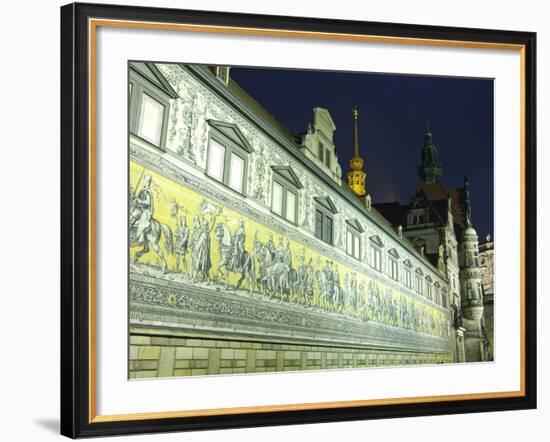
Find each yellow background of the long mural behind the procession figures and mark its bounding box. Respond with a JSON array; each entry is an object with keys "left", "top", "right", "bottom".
[{"left": 130, "top": 162, "right": 449, "bottom": 337}]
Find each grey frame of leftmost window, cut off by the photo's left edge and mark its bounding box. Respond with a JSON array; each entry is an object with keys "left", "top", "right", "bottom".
[{"left": 128, "top": 69, "right": 171, "bottom": 152}]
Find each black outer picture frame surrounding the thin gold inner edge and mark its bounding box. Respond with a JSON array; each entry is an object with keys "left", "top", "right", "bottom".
[{"left": 60, "top": 4, "right": 536, "bottom": 438}]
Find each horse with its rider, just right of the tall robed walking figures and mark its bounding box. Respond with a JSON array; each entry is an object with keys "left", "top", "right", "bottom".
[{"left": 216, "top": 223, "right": 255, "bottom": 293}]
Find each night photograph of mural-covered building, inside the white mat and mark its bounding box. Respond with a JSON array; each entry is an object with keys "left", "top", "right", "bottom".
[{"left": 132, "top": 59, "right": 498, "bottom": 380}]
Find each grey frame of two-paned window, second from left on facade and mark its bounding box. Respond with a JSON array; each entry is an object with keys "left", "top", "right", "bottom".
[{"left": 204, "top": 124, "right": 250, "bottom": 197}]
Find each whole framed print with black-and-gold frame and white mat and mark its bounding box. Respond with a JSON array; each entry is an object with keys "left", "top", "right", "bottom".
[{"left": 61, "top": 4, "right": 536, "bottom": 438}]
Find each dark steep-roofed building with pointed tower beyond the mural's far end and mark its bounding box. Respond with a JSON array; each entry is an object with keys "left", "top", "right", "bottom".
[{"left": 375, "top": 128, "right": 492, "bottom": 361}]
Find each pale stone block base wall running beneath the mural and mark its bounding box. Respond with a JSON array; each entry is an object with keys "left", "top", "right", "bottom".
[{"left": 129, "top": 334, "right": 458, "bottom": 379}]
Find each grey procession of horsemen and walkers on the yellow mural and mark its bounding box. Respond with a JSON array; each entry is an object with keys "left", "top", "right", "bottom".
[{"left": 129, "top": 174, "right": 448, "bottom": 336}]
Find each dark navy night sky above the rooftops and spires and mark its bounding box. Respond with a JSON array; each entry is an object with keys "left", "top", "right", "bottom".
[{"left": 231, "top": 68, "right": 494, "bottom": 242}]
